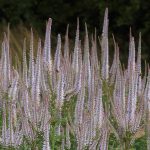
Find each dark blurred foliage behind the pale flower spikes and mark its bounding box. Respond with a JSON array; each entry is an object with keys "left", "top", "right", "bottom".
[{"left": 0, "top": 0, "right": 150, "bottom": 63}]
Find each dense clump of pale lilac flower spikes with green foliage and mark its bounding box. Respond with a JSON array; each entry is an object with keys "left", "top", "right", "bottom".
[{"left": 0, "top": 8, "right": 150, "bottom": 150}]
